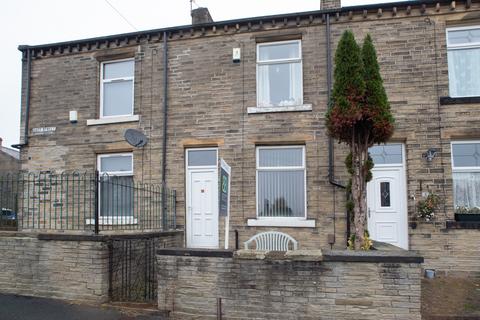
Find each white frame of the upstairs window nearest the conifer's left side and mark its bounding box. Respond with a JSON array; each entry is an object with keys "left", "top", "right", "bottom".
[{"left": 255, "top": 39, "right": 304, "bottom": 108}]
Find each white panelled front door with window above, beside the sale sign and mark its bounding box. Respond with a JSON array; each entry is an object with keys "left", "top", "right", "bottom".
[{"left": 186, "top": 148, "right": 218, "bottom": 248}]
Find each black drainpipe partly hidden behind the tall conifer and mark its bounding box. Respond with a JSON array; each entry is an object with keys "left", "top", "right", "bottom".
[{"left": 325, "top": 13, "right": 350, "bottom": 245}]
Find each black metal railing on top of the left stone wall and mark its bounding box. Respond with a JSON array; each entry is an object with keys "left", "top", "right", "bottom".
[{"left": 0, "top": 172, "right": 176, "bottom": 233}]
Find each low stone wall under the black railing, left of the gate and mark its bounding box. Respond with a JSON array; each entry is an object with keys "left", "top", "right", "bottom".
[{"left": 0, "top": 232, "right": 183, "bottom": 303}]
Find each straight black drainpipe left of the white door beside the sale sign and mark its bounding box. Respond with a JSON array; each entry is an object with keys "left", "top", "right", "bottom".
[{"left": 162, "top": 31, "right": 168, "bottom": 225}]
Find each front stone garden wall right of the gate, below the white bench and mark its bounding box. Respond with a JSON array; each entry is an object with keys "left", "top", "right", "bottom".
[{"left": 157, "top": 249, "right": 422, "bottom": 319}]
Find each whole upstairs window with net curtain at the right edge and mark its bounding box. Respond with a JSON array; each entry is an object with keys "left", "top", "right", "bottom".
[{"left": 447, "top": 26, "right": 480, "bottom": 97}]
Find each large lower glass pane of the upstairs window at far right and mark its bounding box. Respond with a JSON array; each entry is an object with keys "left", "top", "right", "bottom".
[{"left": 448, "top": 48, "right": 480, "bottom": 97}]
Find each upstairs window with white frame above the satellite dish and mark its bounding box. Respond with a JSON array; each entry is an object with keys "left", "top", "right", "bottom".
[{"left": 100, "top": 59, "right": 135, "bottom": 118}]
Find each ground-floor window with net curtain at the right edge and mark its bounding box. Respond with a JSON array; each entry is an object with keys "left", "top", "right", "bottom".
[{"left": 452, "top": 141, "right": 480, "bottom": 211}]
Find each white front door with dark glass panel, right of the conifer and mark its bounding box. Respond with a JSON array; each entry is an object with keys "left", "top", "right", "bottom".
[{"left": 367, "top": 144, "right": 408, "bottom": 249}]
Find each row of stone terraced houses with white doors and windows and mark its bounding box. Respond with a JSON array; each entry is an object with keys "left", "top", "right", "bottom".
[{"left": 7, "top": 0, "right": 480, "bottom": 276}]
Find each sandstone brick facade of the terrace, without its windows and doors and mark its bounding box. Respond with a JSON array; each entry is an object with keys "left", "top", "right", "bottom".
[{"left": 15, "top": 1, "right": 480, "bottom": 269}]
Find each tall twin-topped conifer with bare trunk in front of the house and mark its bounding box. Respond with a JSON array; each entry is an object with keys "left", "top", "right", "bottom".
[{"left": 326, "top": 30, "right": 394, "bottom": 250}]
